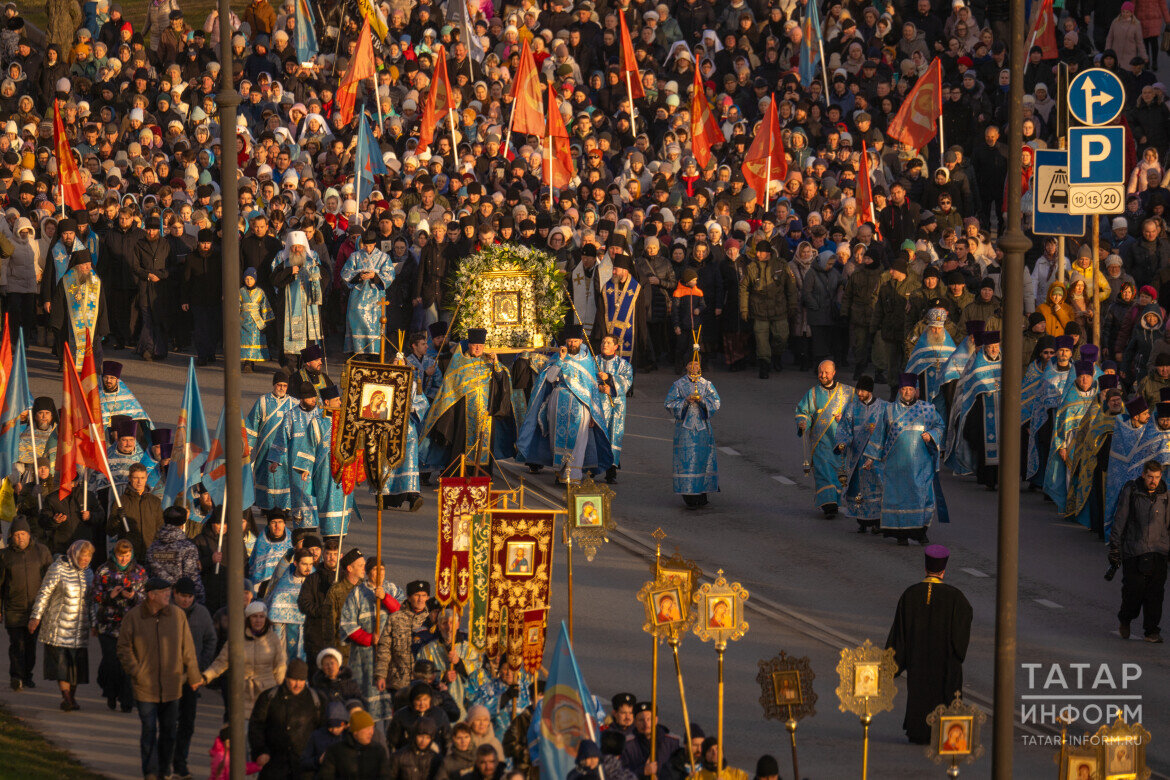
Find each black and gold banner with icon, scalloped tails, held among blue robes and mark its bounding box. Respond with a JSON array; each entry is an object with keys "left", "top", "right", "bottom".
[{"left": 330, "top": 359, "right": 414, "bottom": 491}]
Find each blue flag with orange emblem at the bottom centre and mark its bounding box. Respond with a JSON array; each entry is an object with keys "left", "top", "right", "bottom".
[{"left": 528, "top": 621, "right": 599, "bottom": 780}]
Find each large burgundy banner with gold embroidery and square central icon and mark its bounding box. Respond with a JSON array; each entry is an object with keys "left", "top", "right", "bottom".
[{"left": 484, "top": 509, "right": 556, "bottom": 656}]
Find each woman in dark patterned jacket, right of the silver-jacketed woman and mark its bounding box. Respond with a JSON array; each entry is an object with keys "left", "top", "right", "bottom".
[{"left": 94, "top": 539, "right": 146, "bottom": 712}]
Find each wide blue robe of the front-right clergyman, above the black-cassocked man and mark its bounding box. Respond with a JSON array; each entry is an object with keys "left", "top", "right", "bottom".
[{"left": 865, "top": 400, "right": 947, "bottom": 531}]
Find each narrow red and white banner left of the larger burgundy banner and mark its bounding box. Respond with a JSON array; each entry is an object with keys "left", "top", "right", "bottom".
[{"left": 435, "top": 476, "right": 491, "bottom": 607}]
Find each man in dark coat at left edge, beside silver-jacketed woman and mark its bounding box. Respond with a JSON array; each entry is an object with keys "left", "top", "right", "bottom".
[{"left": 0, "top": 516, "right": 53, "bottom": 691}]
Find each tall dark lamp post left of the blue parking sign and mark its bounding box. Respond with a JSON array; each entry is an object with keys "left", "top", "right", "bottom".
[{"left": 991, "top": 2, "right": 1031, "bottom": 780}]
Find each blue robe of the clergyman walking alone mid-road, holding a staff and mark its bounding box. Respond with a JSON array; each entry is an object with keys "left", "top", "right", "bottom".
[{"left": 666, "top": 377, "right": 720, "bottom": 496}]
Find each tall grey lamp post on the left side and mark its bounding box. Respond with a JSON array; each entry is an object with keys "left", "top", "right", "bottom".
[{"left": 215, "top": 0, "right": 248, "bottom": 780}]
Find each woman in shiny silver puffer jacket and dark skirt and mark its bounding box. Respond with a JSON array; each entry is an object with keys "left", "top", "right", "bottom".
[{"left": 28, "top": 539, "right": 94, "bottom": 712}]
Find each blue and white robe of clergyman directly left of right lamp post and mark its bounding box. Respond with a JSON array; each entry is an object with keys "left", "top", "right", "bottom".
[{"left": 943, "top": 350, "right": 1003, "bottom": 477}]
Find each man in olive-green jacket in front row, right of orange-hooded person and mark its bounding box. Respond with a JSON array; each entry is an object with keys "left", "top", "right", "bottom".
[{"left": 739, "top": 240, "right": 799, "bottom": 379}]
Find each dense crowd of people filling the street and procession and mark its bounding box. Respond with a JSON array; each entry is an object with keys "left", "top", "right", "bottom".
[{"left": 0, "top": 0, "right": 1170, "bottom": 780}]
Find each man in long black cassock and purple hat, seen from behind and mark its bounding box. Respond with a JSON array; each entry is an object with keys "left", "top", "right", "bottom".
[{"left": 886, "top": 545, "right": 971, "bottom": 745}]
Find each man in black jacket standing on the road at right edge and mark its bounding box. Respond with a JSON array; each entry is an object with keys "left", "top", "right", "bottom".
[{"left": 1109, "top": 460, "right": 1170, "bottom": 643}]
